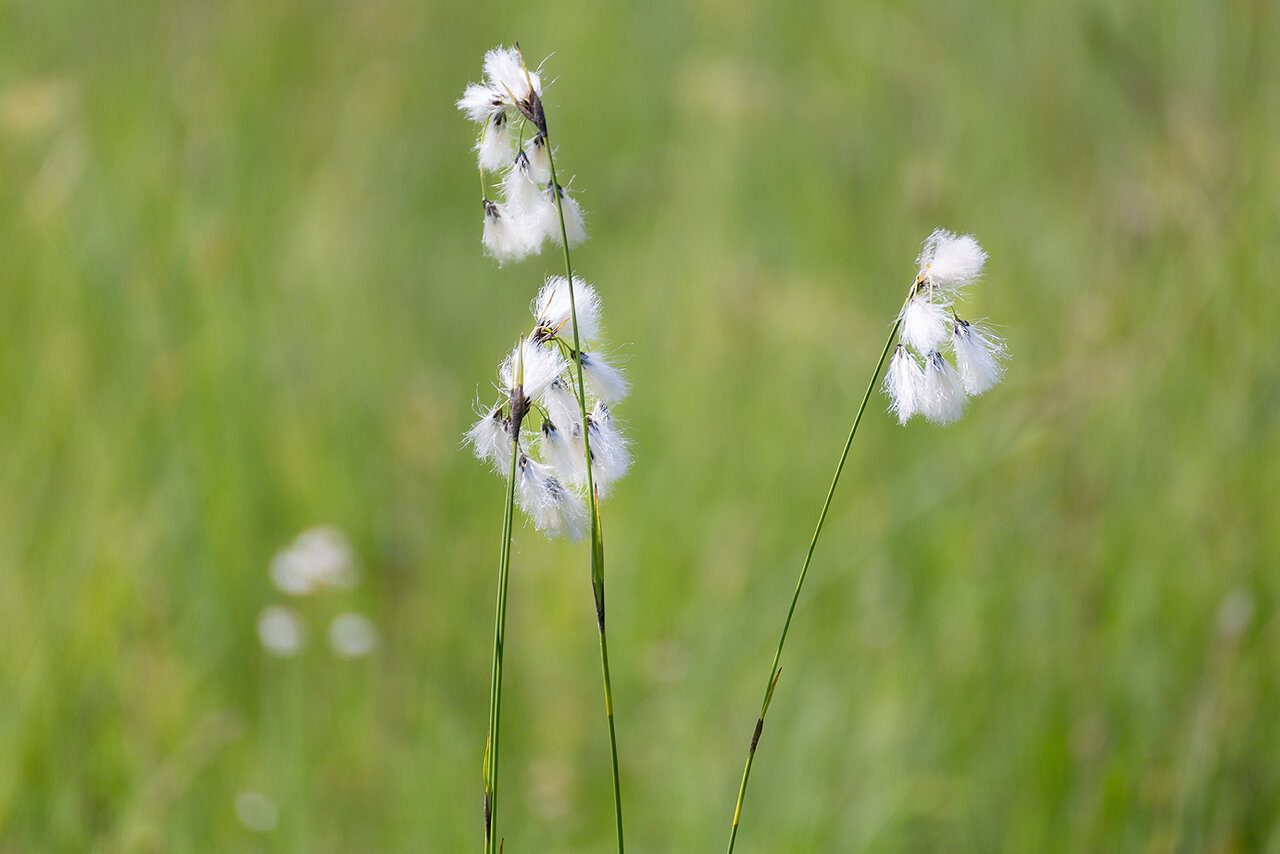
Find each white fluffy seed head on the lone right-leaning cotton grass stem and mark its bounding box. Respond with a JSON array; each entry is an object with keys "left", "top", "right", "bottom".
[{"left": 884, "top": 228, "right": 1007, "bottom": 425}]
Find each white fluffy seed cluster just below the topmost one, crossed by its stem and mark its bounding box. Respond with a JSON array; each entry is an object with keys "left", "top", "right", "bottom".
[{"left": 466, "top": 277, "right": 632, "bottom": 539}]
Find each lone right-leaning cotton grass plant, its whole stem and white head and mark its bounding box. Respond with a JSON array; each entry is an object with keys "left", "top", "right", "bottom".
[{"left": 728, "top": 229, "right": 1007, "bottom": 854}]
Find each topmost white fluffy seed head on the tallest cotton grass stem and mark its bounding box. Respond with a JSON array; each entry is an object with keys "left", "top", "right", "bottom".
[{"left": 458, "top": 46, "right": 586, "bottom": 264}]
